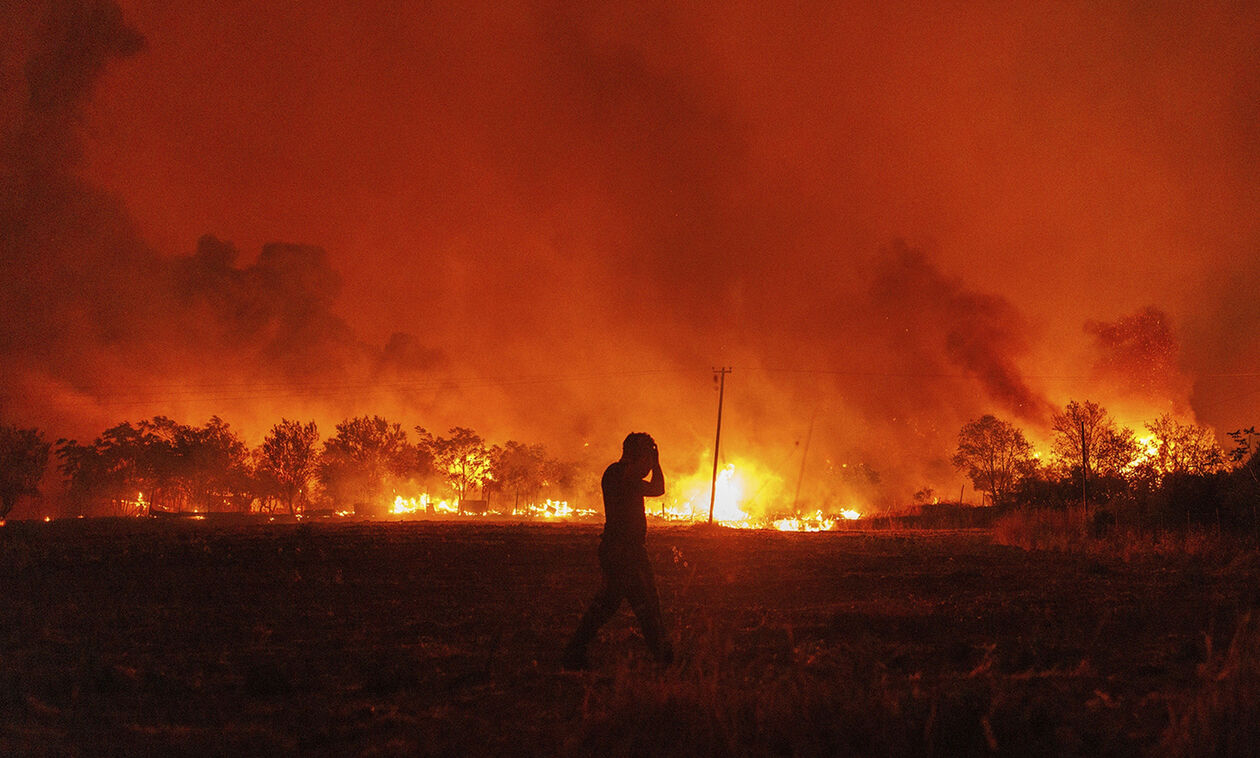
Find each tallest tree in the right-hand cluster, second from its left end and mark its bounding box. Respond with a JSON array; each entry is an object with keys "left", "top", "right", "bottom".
[{"left": 1052, "top": 400, "right": 1138, "bottom": 501}]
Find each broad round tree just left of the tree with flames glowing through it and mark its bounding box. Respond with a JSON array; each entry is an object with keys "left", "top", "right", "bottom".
[{"left": 319, "top": 416, "right": 415, "bottom": 507}]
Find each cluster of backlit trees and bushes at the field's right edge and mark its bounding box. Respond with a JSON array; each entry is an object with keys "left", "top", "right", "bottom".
[{"left": 953, "top": 400, "right": 1260, "bottom": 529}]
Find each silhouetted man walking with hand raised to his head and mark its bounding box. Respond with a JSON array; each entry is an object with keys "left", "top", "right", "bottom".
[{"left": 564, "top": 432, "right": 674, "bottom": 669}]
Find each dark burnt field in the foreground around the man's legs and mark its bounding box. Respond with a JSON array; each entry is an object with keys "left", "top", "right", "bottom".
[{"left": 0, "top": 520, "right": 1260, "bottom": 755}]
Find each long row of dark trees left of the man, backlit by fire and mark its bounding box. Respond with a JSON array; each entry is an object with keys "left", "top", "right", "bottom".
[{"left": 0, "top": 416, "right": 577, "bottom": 519}]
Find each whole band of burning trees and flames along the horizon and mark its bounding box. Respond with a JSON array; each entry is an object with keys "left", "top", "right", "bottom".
[{"left": 0, "top": 390, "right": 1260, "bottom": 531}]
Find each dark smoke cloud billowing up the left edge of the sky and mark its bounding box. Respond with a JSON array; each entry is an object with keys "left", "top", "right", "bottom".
[{"left": 0, "top": 1, "right": 440, "bottom": 434}]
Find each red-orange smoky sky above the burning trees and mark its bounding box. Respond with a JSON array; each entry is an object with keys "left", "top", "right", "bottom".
[{"left": 4, "top": 0, "right": 1260, "bottom": 503}]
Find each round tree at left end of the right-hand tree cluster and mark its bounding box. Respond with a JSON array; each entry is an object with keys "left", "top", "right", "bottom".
[{"left": 953, "top": 414, "right": 1036, "bottom": 505}]
